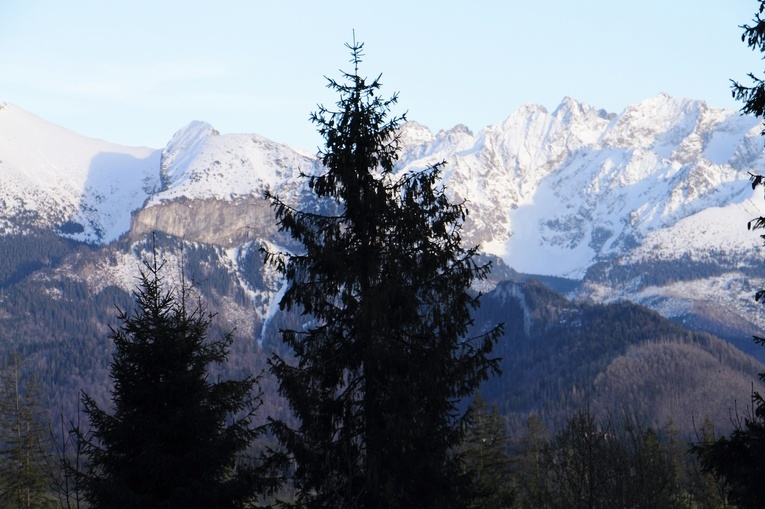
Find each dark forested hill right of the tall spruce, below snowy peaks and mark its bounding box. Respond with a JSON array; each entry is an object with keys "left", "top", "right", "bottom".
[{"left": 476, "top": 280, "right": 762, "bottom": 431}]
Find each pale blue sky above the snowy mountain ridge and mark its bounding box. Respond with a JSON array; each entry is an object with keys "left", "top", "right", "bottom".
[{"left": 0, "top": 0, "right": 765, "bottom": 152}]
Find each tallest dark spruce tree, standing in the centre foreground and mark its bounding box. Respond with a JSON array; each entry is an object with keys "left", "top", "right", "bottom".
[{"left": 266, "top": 41, "right": 500, "bottom": 509}]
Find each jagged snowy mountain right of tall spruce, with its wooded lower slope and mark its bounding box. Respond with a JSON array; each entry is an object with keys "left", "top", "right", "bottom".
[{"left": 390, "top": 95, "right": 765, "bottom": 353}]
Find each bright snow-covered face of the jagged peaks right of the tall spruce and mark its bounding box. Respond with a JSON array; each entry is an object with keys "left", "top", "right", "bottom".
[{"left": 390, "top": 95, "right": 765, "bottom": 278}]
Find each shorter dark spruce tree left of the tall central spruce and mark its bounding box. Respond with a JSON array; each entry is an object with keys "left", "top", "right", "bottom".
[{"left": 72, "top": 253, "right": 269, "bottom": 509}]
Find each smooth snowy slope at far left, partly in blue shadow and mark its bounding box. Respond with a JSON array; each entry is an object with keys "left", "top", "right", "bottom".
[{"left": 0, "top": 104, "right": 160, "bottom": 242}]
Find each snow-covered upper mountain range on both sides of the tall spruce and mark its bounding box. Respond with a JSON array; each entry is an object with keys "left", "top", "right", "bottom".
[{"left": 0, "top": 95, "right": 765, "bottom": 348}]
